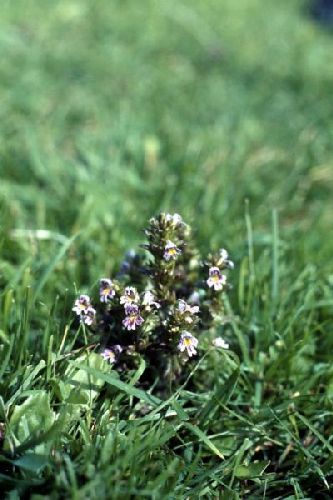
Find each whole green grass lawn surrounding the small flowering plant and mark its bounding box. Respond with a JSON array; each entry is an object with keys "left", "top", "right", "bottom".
[{"left": 0, "top": 0, "right": 333, "bottom": 499}]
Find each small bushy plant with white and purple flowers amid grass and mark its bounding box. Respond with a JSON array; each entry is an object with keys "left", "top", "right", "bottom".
[{"left": 73, "top": 213, "right": 234, "bottom": 382}]
